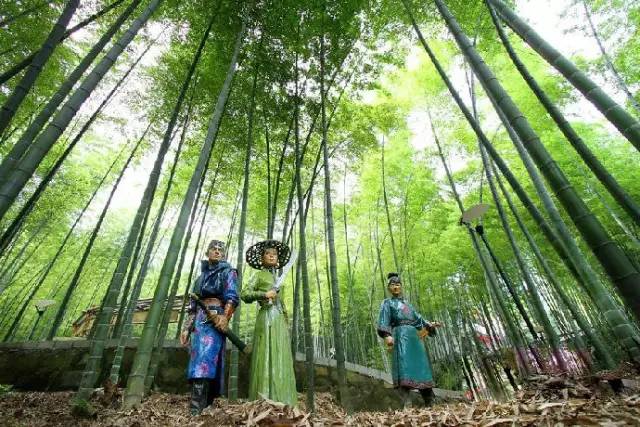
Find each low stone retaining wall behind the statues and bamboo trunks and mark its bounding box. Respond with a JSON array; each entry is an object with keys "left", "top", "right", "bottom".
[{"left": 0, "top": 339, "right": 462, "bottom": 410}]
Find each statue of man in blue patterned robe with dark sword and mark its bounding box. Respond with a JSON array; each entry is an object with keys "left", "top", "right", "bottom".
[{"left": 180, "top": 240, "right": 239, "bottom": 415}]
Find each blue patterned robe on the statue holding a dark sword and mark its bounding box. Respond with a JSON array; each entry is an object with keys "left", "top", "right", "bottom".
[{"left": 187, "top": 261, "right": 239, "bottom": 395}]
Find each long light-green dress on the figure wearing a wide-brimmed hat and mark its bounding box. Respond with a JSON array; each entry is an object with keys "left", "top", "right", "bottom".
[{"left": 242, "top": 269, "right": 298, "bottom": 406}]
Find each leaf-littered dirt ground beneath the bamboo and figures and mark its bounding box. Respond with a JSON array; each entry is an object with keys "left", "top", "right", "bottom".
[{"left": 0, "top": 377, "right": 640, "bottom": 427}]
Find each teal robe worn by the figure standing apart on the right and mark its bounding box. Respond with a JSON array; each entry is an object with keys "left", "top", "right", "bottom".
[{"left": 378, "top": 297, "right": 435, "bottom": 390}]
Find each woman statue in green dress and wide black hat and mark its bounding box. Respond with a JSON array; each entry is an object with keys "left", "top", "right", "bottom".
[{"left": 241, "top": 240, "right": 298, "bottom": 406}]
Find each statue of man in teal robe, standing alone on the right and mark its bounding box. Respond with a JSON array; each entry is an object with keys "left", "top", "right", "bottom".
[{"left": 378, "top": 273, "right": 441, "bottom": 407}]
